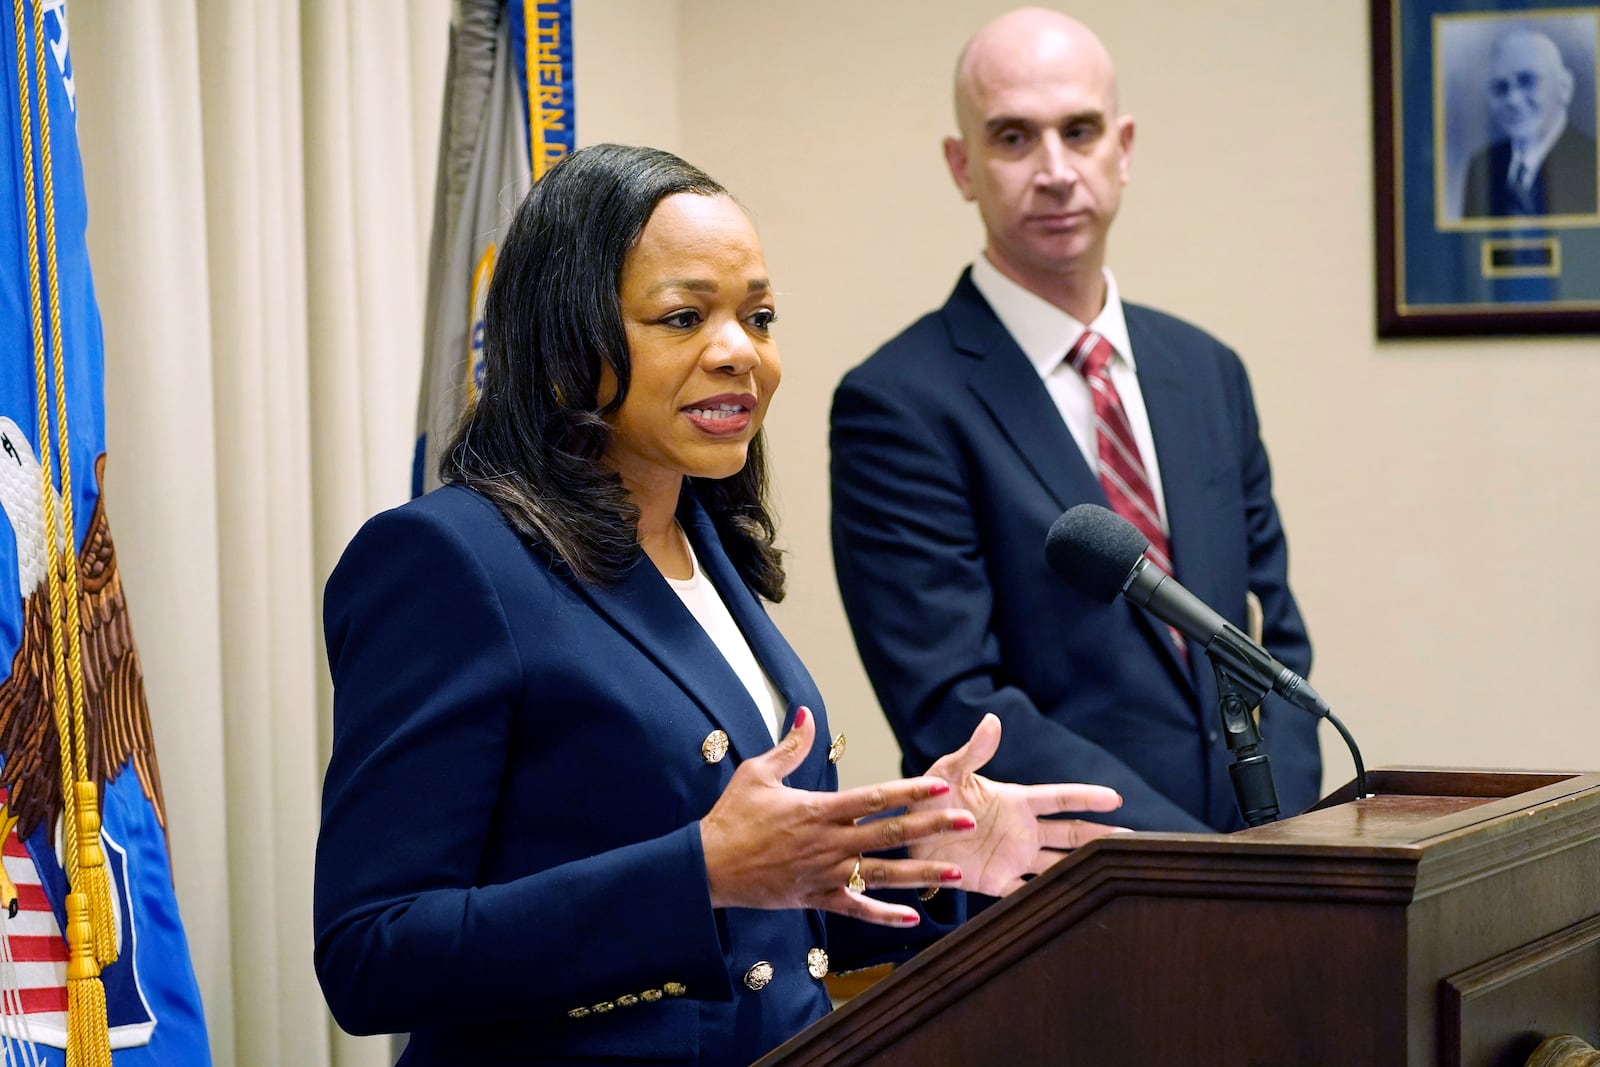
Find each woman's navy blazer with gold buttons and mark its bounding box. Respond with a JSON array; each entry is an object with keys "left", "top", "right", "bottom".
[{"left": 315, "top": 488, "right": 960, "bottom": 1065}]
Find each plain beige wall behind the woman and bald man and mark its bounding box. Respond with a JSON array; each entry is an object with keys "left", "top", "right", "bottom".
[{"left": 576, "top": 0, "right": 1600, "bottom": 787}]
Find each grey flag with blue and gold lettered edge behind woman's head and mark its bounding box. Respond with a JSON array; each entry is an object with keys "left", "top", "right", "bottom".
[{"left": 411, "top": 0, "right": 576, "bottom": 496}]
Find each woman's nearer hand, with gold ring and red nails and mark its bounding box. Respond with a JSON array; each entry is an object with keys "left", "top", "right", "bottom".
[{"left": 701, "top": 707, "right": 978, "bottom": 926}]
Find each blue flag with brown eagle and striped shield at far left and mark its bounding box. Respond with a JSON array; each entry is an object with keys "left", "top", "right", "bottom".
[{"left": 0, "top": 0, "right": 210, "bottom": 1067}]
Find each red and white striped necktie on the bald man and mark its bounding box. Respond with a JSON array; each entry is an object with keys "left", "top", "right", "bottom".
[{"left": 1067, "top": 330, "right": 1189, "bottom": 662}]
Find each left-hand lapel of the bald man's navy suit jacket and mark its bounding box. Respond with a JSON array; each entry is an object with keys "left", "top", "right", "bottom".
[{"left": 944, "top": 270, "right": 1106, "bottom": 510}]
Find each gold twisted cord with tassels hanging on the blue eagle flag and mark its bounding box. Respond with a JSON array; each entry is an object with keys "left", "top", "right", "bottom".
[{"left": 13, "top": 0, "right": 117, "bottom": 1067}]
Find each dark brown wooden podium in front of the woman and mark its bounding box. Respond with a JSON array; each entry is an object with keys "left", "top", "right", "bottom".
[{"left": 760, "top": 769, "right": 1600, "bottom": 1067}]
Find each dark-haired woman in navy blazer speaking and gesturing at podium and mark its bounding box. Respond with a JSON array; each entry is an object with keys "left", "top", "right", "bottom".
[{"left": 305, "top": 146, "right": 1120, "bottom": 1065}]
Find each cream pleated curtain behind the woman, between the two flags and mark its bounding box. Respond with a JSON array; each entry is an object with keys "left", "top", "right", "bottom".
[{"left": 69, "top": 0, "right": 450, "bottom": 1067}]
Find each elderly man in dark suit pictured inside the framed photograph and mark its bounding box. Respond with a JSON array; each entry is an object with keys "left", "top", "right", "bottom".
[{"left": 1461, "top": 27, "right": 1600, "bottom": 219}]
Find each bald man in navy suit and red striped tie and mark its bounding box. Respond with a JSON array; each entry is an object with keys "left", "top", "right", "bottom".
[{"left": 830, "top": 8, "right": 1322, "bottom": 832}]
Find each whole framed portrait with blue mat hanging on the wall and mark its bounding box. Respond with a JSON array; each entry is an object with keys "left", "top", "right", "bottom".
[{"left": 1371, "top": 0, "right": 1600, "bottom": 338}]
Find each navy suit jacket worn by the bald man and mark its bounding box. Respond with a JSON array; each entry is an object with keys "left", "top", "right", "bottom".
[{"left": 830, "top": 274, "right": 1322, "bottom": 832}]
